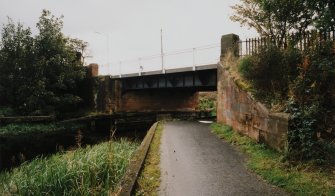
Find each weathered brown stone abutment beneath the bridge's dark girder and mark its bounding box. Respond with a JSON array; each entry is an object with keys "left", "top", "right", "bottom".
[{"left": 88, "top": 68, "right": 198, "bottom": 113}]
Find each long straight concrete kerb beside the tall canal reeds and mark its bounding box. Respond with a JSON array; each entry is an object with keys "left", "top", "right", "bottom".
[{"left": 112, "top": 122, "right": 158, "bottom": 196}]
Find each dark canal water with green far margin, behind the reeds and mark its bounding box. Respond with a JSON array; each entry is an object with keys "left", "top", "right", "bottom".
[{"left": 0, "top": 116, "right": 154, "bottom": 171}]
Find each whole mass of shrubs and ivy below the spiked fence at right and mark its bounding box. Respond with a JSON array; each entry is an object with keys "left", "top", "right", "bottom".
[{"left": 238, "top": 42, "right": 335, "bottom": 163}]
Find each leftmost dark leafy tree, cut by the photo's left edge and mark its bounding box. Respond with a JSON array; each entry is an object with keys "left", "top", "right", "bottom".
[{"left": 0, "top": 19, "right": 35, "bottom": 107}]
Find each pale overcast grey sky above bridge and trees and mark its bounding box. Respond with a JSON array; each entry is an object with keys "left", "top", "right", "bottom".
[{"left": 0, "top": 0, "right": 257, "bottom": 74}]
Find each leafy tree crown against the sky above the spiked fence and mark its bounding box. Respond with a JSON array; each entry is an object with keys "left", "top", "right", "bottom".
[{"left": 231, "top": 0, "right": 313, "bottom": 43}]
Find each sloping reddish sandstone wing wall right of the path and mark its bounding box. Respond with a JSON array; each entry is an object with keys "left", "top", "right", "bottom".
[{"left": 217, "top": 35, "right": 289, "bottom": 151}]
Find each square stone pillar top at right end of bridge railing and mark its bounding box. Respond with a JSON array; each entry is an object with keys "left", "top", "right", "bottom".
[{"left": 220, "top": 34, "right": 240, "bottom": 61}]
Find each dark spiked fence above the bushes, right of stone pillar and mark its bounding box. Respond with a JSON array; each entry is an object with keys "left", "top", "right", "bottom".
[{"left": 237, "top": 31, "right": 335, "bottom": 56}]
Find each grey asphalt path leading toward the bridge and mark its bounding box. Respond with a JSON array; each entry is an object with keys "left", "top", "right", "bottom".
[{"left": 159, "top": 121, "right": 286, "bottom": 196}]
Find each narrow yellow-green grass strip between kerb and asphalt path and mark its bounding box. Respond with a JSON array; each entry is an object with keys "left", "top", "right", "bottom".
[{"left": 135, "top": 122, "right": 163, "bottom": 196}]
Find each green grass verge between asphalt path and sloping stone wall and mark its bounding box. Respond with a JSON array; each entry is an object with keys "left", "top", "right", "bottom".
[{"left": 211, "top": 123, "right": 335, "bottom": 195}]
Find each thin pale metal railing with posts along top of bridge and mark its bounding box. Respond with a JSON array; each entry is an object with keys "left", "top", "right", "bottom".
[{"left": 99, "top": 43, "right": 221, "bottom": 77}]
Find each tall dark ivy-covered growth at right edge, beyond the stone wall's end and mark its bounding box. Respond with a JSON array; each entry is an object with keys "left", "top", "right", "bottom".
[{"left": 288, "top": 43, "right": 335, "bottom": 162}]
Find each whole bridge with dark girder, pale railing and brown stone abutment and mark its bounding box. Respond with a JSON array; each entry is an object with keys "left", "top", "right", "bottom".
[{"left": 91, "top": 34, "right": 239, "bottom": 113}]
